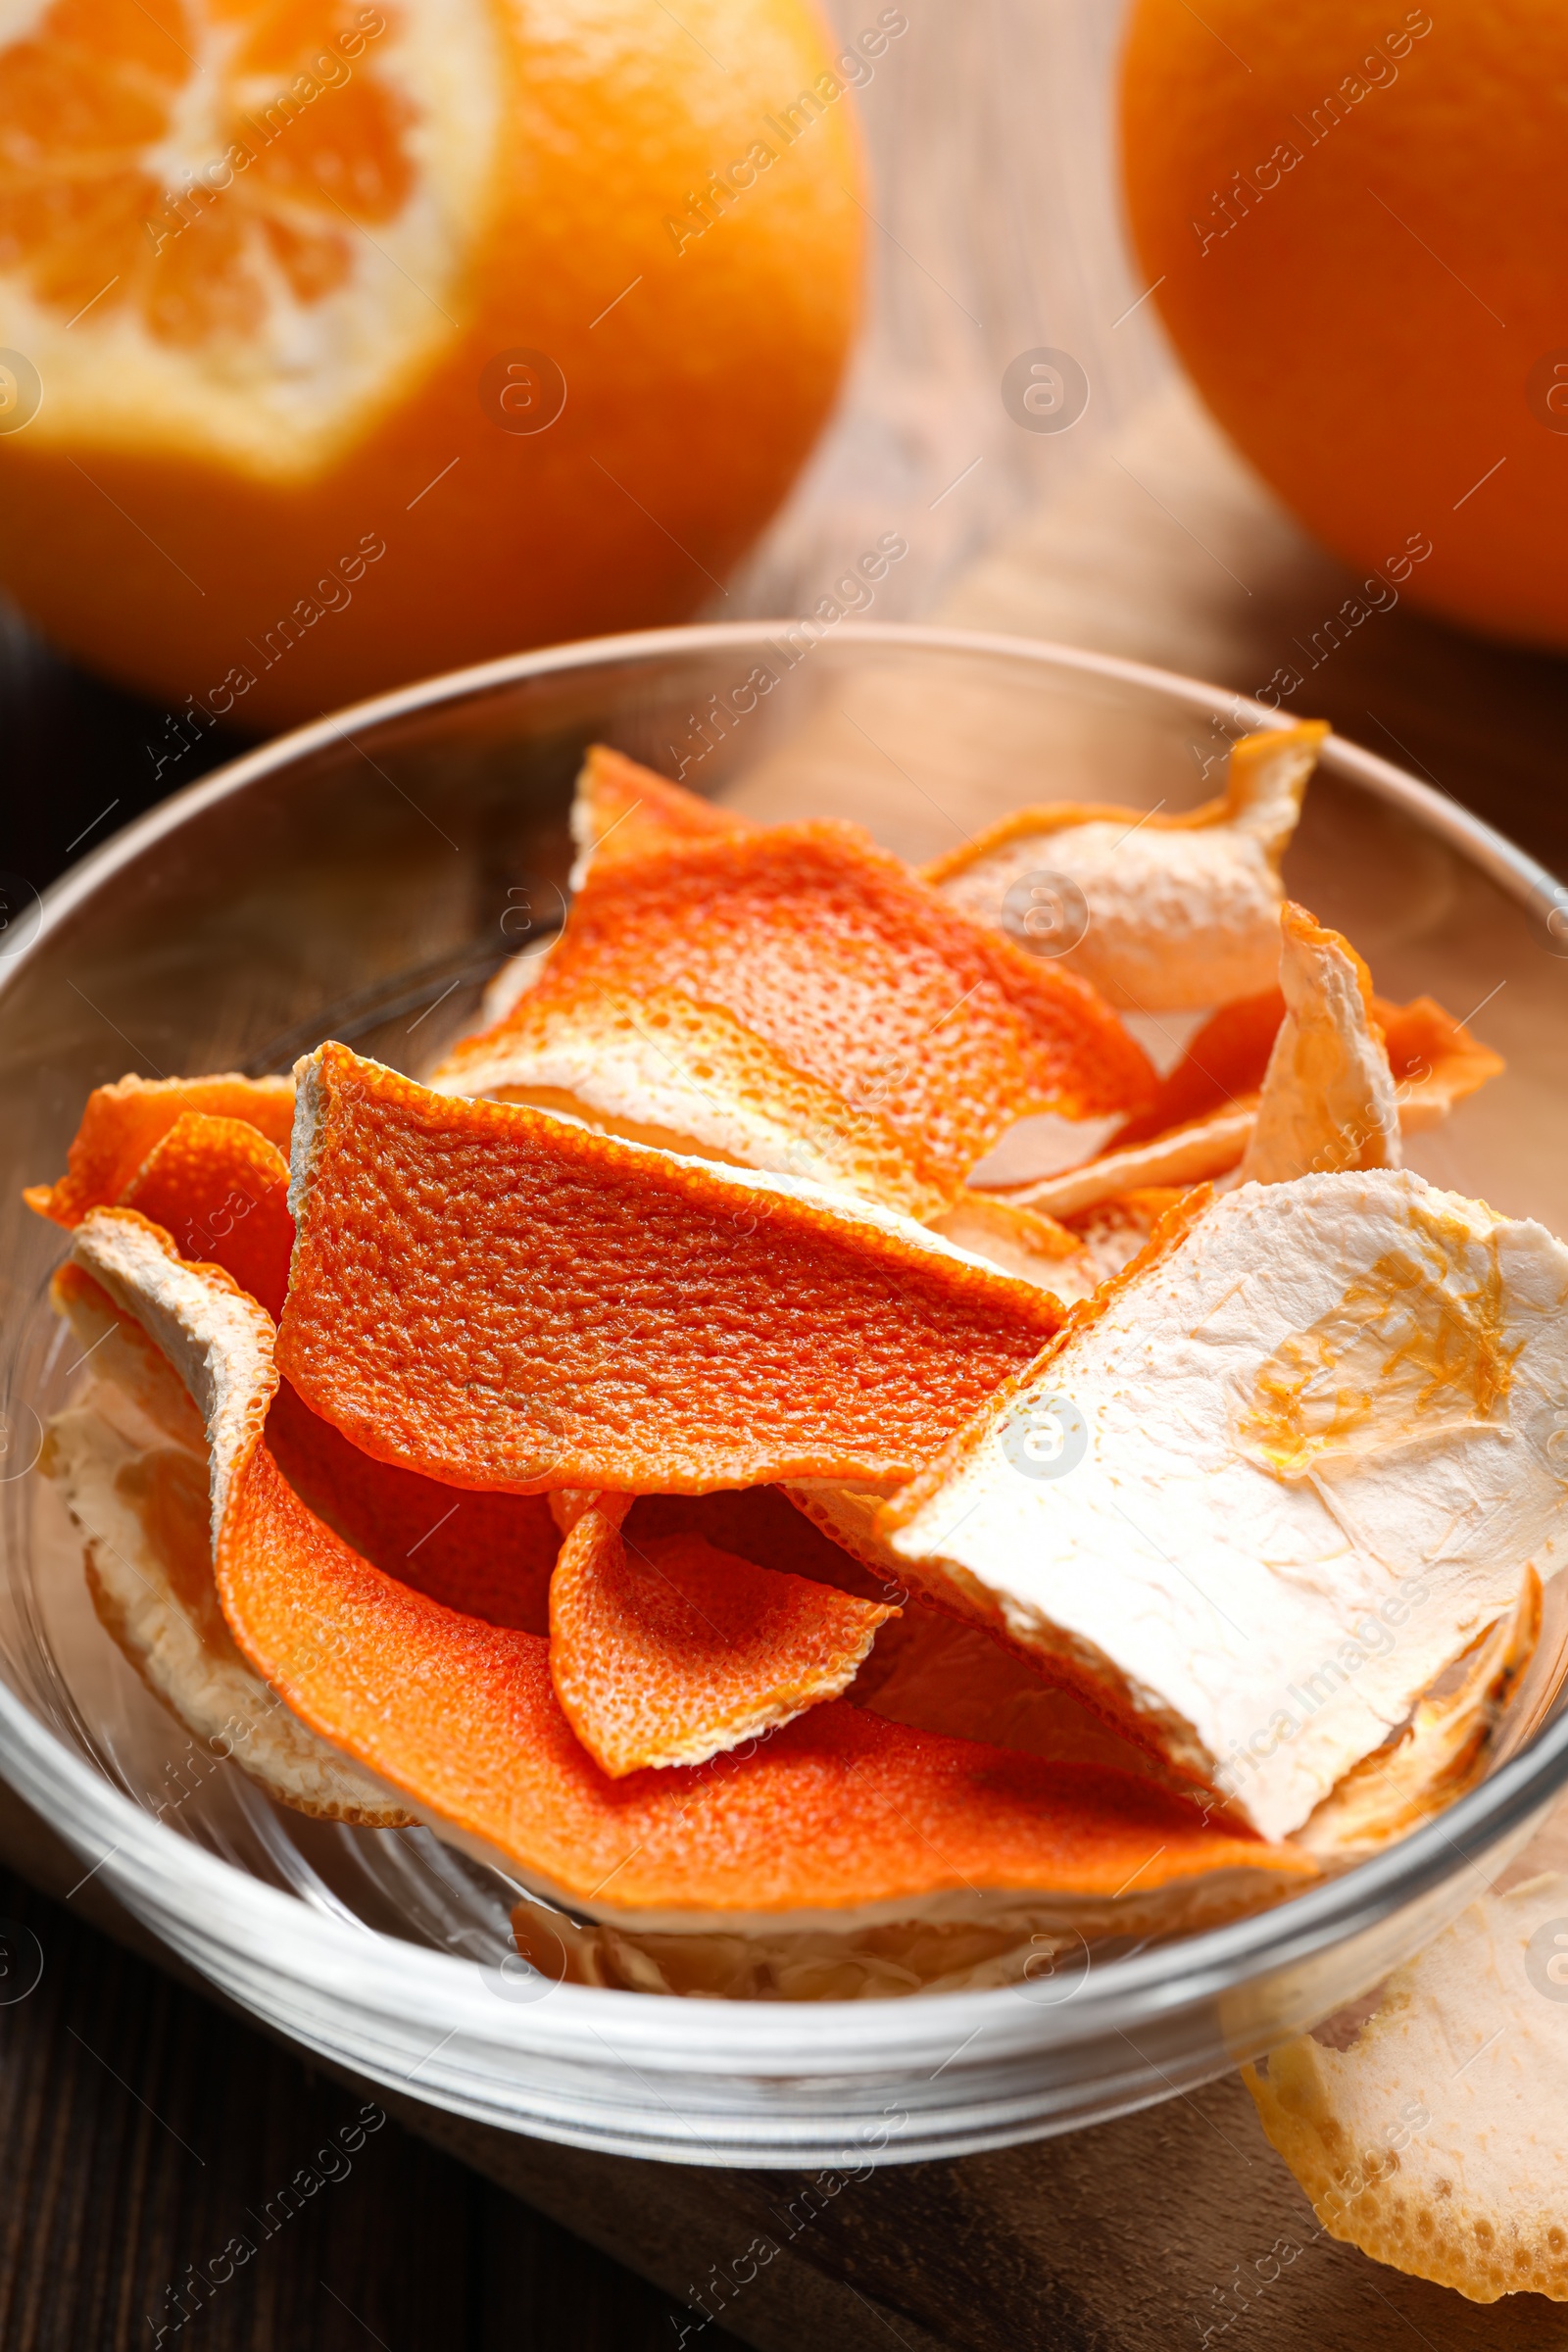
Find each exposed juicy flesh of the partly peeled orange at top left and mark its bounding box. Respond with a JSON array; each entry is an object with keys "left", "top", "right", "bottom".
[{"left": 0, "top": 0, "right": 414, "bottom": 348}]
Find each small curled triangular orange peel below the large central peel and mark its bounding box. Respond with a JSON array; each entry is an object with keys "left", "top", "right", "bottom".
[{"left": 550, "top": 1510, "right": 898, "bottom": 1781}]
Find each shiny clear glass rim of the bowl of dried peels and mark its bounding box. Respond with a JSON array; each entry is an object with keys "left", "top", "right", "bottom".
[{"left": 0, "top": 621, "right": 1568, "bottom": 2097}]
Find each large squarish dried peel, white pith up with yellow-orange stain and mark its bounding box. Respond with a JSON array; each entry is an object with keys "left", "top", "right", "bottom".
[{"left": 886, "top": 1169, "right": 1568, "bottom": 1837}]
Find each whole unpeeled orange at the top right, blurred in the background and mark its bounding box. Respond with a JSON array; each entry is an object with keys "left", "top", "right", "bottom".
[{"left": 1121, "top": 0, "right": 1568, "bottom": 645}]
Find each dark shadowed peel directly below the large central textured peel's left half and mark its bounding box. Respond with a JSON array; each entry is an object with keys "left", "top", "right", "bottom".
[{"left": 266, "top": 1381, "right": 560, "bottom": 1635}]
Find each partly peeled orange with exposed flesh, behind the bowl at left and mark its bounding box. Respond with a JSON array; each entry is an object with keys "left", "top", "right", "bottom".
[{"left": 0, "top": 0, "right": 869, "bottom": 727}]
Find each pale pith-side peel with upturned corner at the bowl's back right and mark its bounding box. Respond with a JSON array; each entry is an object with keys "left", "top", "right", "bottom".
[{"left": 926, "top": 719, "right": 1328, "bottom": 1011}]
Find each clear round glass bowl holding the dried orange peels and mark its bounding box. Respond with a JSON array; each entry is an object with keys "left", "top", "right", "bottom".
[{"left": 0, "top": 621, "right": 1568, "bottom": 2166}]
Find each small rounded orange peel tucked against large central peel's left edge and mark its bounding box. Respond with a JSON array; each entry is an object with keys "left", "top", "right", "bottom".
[{"left": 120, "top": 1110, "right": 294, "bottom": 1322}]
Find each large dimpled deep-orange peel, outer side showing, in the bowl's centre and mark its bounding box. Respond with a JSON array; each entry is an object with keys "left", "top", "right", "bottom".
[{"left": 277, "top": 1045, "right": 1062, "bottom": 1494}]
